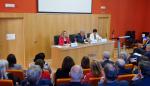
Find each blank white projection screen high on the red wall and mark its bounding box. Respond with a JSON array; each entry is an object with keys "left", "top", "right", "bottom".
[{"left": 38, "top": 0, "right": 92, "bottom": 13}]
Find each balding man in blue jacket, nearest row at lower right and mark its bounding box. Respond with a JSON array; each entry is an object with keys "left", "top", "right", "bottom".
[{"left": 98, "top": 63, "right": 128, "bottom": 86}]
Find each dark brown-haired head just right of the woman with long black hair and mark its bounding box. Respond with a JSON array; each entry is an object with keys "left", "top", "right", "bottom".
[{"left": 81, "top": 56, "right": 90, "bottom": 69}]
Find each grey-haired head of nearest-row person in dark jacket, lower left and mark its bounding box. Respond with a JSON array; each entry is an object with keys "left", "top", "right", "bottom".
[{"left": 27, "top": 65, "right": 42, "bottom": 85}]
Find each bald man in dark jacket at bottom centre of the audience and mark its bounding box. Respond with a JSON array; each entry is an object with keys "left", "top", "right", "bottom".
[{"left": 60, "top": 65, "right": 90, "bottom": 86}]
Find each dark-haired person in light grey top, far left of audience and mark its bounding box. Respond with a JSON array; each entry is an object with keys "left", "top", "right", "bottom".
[{"left": 7, "top": 54, "right": 22, "bottom": 70}]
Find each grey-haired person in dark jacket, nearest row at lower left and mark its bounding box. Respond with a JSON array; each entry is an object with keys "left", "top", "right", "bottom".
[{"left": 21, "top": 65, "right": 53, "bottom": 86}]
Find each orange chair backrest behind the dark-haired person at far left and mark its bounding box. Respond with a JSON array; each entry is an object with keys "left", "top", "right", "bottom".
[{"left": 7, "top": 70, "right": 25, "bottom": 81}]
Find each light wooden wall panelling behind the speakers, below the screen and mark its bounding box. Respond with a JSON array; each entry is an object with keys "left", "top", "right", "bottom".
[{"left": 0, "top": 13, "right": 110, "bottom": 67}]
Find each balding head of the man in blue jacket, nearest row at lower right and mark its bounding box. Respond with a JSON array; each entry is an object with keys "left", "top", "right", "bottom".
[{"left": 104, "top": 64, "right": 118, "bottom": 81}]
